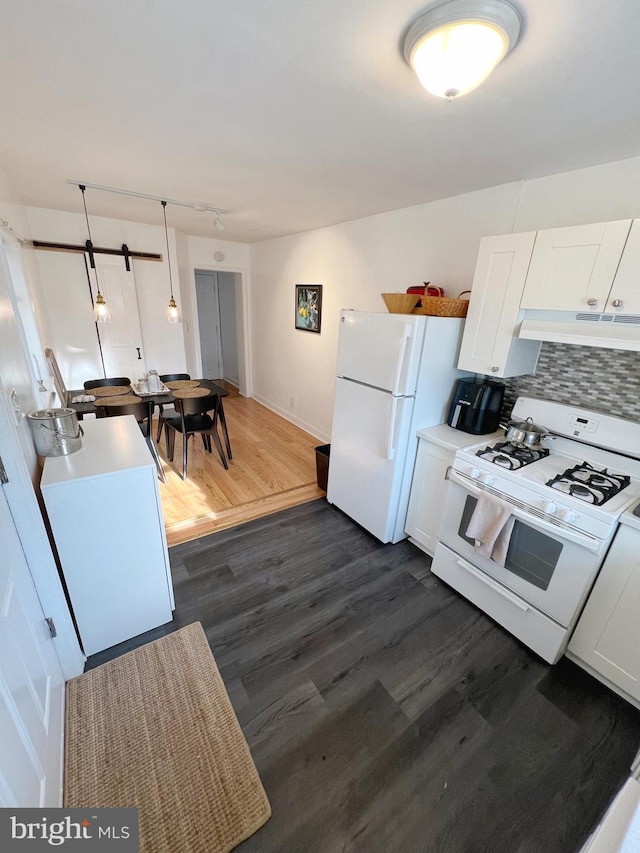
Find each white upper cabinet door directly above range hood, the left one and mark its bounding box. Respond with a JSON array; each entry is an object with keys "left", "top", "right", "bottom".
[{"left": 521, "top": 219, "right": 640, "bottom": 313}]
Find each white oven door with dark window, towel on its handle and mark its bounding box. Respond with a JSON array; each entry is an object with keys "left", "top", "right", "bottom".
[{"left": 438, "top": 471, "right": 604, "bottom": 627}]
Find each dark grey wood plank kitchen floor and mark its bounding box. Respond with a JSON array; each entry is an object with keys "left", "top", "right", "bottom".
[{"left": 88, "top": 500, "right": 640, "bottom": 853}]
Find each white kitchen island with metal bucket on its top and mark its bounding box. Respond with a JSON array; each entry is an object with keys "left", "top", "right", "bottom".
[{"left": 41, "top": 415, "right": 174, "bottom": 655}]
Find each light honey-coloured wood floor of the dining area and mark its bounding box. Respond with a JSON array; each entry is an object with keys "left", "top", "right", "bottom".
[{"left": 154, "top": 392, "right": 324, "bottom": 545}]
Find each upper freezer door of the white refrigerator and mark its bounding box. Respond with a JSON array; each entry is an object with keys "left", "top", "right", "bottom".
[{"left": 336, "top": 311, "right": 426, "bottom": 395}]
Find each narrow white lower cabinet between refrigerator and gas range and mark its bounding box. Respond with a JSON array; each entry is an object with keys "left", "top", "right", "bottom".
[{"left": 405, "top": 436, "right": 456, "bottom": 556}]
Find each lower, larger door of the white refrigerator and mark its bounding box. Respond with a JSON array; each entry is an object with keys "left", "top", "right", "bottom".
[{"left": 327, "top": 379, "right": 414, "bottom": 542}]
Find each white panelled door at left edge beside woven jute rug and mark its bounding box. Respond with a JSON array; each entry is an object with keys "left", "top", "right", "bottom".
[{"left": 0, "top": 486, "right": 64, "bottom": 808}]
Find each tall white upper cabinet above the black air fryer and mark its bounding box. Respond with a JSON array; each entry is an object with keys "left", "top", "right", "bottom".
[{"left": 458, "top": 231, "right": 540, "bottom": 377}]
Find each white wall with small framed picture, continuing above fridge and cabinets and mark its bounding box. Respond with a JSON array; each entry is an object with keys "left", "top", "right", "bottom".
[{"left": 251, "top": 158, "right": 640, "bottom": 440}]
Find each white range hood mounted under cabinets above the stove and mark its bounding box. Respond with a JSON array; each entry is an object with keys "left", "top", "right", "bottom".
[{"left": 518, "top": 310, "right": 640, "bottom": 352}]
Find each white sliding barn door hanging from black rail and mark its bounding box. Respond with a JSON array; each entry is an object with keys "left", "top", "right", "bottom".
[{"left": 90, "top": 255, "right": 146, "bottom": 382}]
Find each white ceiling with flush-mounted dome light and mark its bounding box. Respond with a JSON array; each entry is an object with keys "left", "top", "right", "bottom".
[{"left": 0, "top": 0, "right": 640, "bottom": 242}]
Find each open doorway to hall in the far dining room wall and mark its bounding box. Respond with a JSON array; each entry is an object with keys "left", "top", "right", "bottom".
[{"left": 195, "top": 270, "right": 242, "bottom": 388}]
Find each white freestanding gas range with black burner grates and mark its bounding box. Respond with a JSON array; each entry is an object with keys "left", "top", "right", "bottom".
[{"left": 432, "top": 397, "right": 640, "bottom": 663}]
